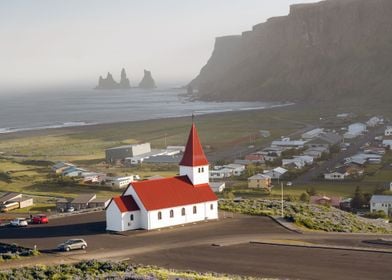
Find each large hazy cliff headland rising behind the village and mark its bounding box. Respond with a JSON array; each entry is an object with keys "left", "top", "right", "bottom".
[{"left": 189, "top": 0, "right": 392, "bottom": 104}]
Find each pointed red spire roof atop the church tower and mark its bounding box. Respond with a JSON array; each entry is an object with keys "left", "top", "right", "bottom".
[{"left": 180, "top": 124, "right": 208, "bottom": 166}]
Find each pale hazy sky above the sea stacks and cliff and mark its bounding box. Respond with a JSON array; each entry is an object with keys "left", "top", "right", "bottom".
[{"left": 0, "top": 0, "right": 317, "bottom": 90}]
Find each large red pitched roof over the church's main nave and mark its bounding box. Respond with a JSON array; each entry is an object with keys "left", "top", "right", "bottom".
[{"left": 129, "top": 176, "right": 218, "bottom": 211}]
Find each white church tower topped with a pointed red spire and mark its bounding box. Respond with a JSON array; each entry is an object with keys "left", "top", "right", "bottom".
[{"left": 180, "top": 123, "right": 209, "bottom": 186}]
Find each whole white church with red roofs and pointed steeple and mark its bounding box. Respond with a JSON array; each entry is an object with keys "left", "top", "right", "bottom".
[{"left": 106, "top": 124, "right": 218, "bottom": 231}]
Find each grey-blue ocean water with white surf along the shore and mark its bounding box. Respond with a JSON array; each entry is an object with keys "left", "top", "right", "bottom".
[{"left": 0, "top": 88, "right": 282, "bottom": 133}]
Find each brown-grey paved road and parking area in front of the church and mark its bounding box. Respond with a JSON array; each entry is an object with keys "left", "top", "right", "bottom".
[{"left": 0, "top": 212, "right": 392, "bottom": 279}]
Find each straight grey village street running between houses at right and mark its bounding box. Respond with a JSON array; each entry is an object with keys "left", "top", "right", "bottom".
[{"left": 293, "top": 127, "right": 384, "bottom": 185}]
